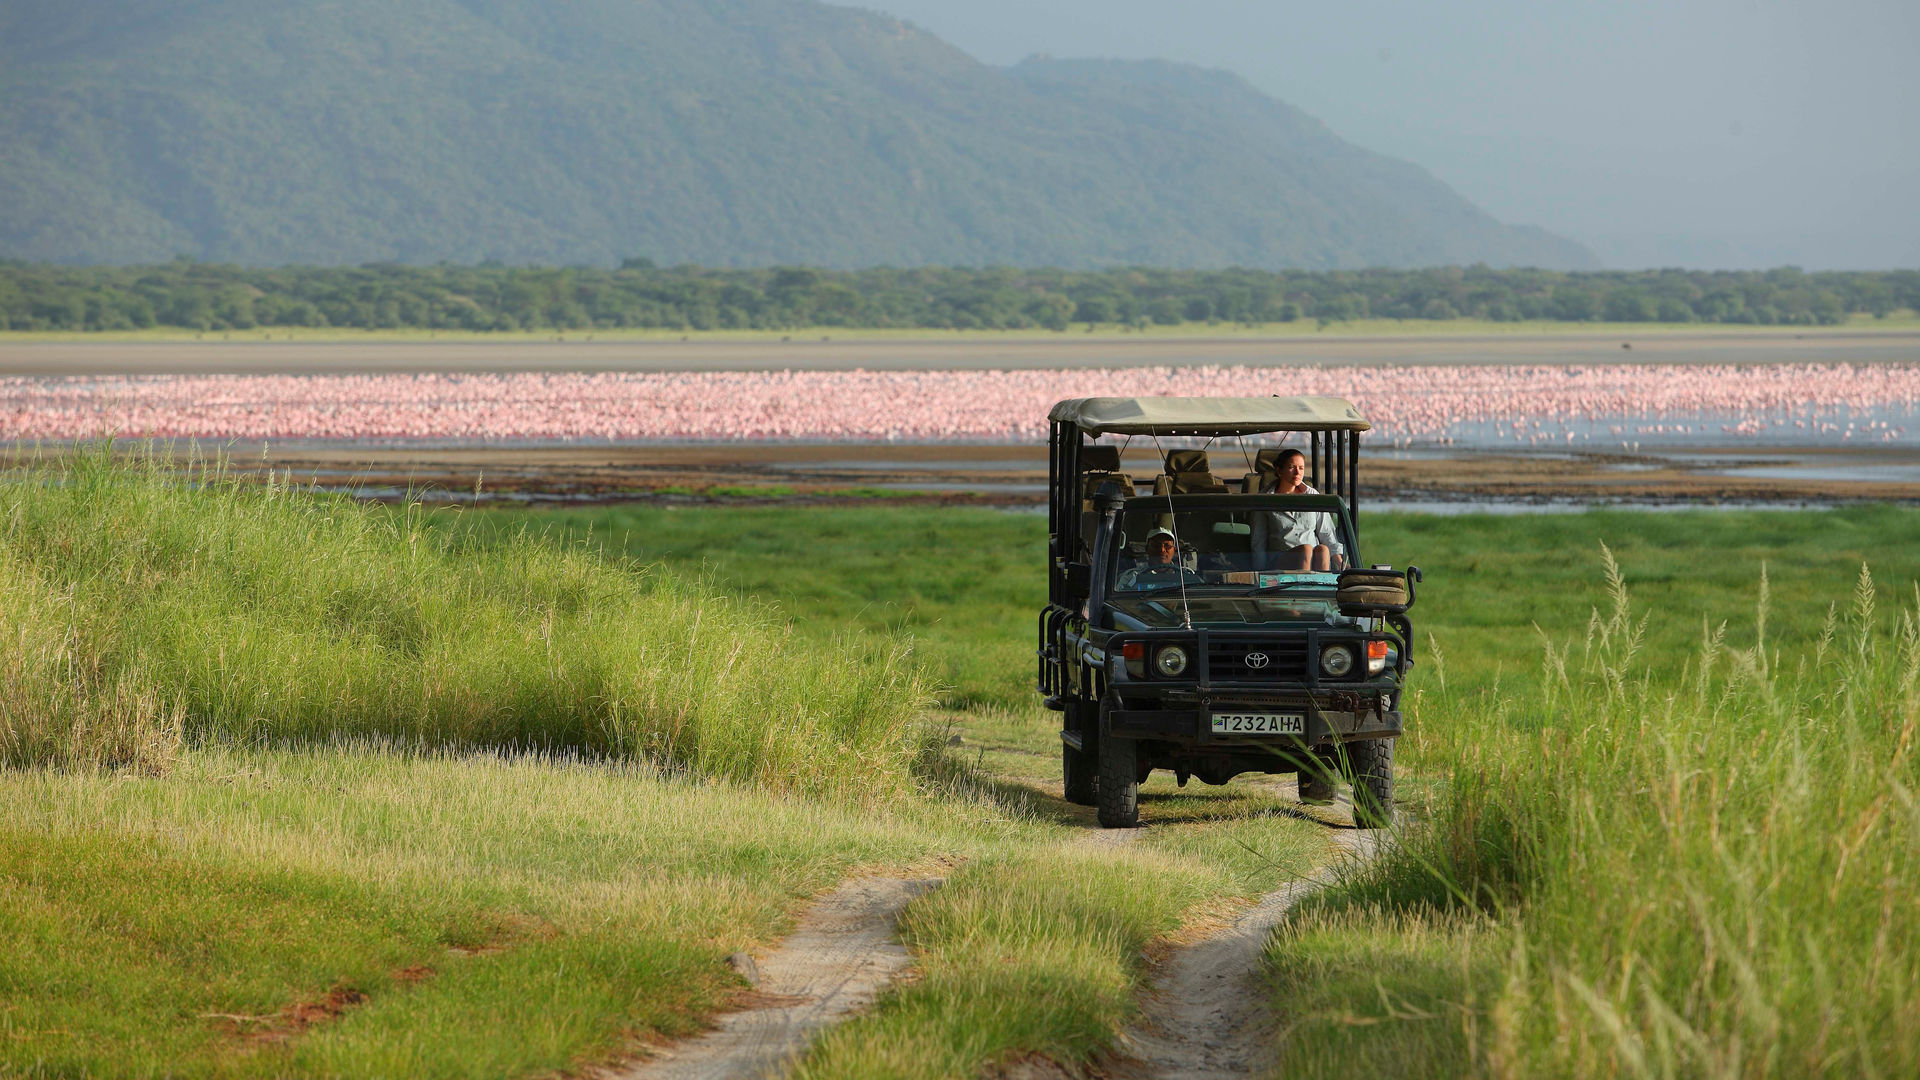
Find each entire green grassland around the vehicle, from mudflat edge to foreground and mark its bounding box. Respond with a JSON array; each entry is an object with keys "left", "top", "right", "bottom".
[{"left": 0, "top": 463, "right": 1920, "bottom": 1076}]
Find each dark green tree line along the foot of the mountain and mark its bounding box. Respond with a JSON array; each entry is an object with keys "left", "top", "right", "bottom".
[{"left": 0, "top": 259, "right": 1920, "bottom": 331}]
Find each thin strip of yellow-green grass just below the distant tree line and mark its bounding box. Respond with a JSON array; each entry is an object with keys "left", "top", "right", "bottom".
[{"left": 0, "top": 309, "right": 1920, "bottom": 344}]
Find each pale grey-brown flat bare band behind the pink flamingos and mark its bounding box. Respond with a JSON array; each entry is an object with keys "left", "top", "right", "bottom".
[{"left": 0, "top": 329, "right": 1920, "bottom": 377}]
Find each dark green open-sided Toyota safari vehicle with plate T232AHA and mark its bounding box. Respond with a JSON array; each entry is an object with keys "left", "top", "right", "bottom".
[{"left": 1039, "top": 398, "right": 1421, "bottom": 828}]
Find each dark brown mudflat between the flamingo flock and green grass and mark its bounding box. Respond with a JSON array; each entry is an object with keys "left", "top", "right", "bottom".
[{"left": 82, "top": 442, "right": 1920, "bottom": 507}]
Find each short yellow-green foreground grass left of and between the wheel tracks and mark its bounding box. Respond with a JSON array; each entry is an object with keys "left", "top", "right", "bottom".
[{"left": 0, "top": 726, "right": 1323, "bottom": 1078}]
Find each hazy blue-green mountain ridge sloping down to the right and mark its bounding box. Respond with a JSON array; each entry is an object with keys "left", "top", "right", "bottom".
[{"left": 0, "top": 0, "right": 1597, "bottom": 269}]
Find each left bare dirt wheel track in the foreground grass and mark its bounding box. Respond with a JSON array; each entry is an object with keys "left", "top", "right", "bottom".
[{"left": 603, "top": 878, "right": 941, "bottom": 1080}]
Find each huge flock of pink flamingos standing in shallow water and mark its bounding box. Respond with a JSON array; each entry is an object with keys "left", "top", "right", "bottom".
[{"left": 0, "top": 363, "right": 1920, "bottom": 446}]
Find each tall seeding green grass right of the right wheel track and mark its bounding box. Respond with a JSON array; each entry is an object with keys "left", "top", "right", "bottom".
[{"left": 1271, "top": 545, "right": 1920, "bottom": 1076}]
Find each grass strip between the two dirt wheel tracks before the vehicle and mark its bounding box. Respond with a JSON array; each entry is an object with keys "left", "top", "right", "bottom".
[{"left": 797, "top": 709, "right": 1331, "bottom": 1080}]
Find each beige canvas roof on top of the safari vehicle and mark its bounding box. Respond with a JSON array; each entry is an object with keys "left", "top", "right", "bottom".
[{"left": 1046, "top": 398, "right": 1373, "bottom": 436}]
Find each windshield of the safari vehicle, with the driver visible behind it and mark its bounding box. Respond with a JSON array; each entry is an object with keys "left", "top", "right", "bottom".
[{"left": 1108, "top": 496, "right": 1354, "bottom": 601}]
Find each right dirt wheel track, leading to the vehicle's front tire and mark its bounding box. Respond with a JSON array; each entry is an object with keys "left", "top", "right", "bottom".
[{"left": 1102, "top": 814, "right": 1382, "bottom": 1080}]
